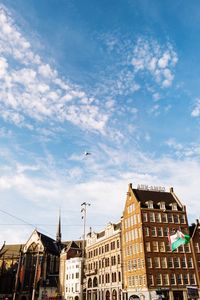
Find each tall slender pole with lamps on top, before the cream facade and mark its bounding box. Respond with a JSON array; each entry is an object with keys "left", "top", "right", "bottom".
[{"left": 80, "top": 202, "right": 90, "bottom": 300}]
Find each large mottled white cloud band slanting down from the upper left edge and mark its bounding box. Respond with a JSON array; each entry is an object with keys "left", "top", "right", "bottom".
[{"left": 0, "top": 7, "right": 109, "bottom": 132}]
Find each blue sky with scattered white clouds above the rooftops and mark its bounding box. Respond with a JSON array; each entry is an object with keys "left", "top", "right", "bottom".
[{"left": 0, "top": 0, "right": 200, "bottom": 244}]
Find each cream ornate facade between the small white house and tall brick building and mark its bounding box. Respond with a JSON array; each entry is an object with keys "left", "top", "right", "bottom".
[{"left": 86, "top": 222, "right": 122, "bottom": 300}]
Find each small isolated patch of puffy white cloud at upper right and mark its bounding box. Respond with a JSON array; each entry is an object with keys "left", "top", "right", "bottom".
[{"left": 131, "top": 38, "right": 178, "bottom": 88}]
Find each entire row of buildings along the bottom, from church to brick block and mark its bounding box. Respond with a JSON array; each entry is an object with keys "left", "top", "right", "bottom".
[{"left": 0, "top": 184, "right": 200, "bottom": 300}]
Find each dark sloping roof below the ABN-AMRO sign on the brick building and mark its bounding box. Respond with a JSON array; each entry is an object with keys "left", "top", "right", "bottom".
[{"left": 132, "top": 189, "right": 182, "bottom": 210}]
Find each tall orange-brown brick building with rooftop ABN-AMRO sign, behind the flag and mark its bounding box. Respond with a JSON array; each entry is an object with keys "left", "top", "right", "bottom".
[{"left": 122, "top": 184, "right": 197, "bottom": 300}]
